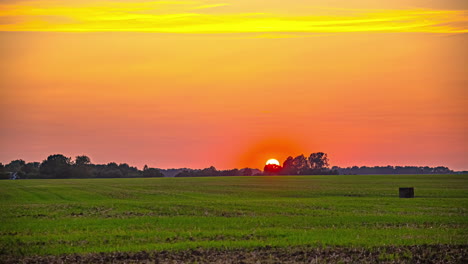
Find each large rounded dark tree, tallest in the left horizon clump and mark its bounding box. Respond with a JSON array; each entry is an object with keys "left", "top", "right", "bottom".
[{"left": 39, "top": 154, "right": 72, "bottom": 178}]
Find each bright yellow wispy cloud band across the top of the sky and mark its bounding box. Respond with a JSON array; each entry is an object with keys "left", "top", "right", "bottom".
[{"left": 0, "top": 1, "right": 468, "bottom": 33}]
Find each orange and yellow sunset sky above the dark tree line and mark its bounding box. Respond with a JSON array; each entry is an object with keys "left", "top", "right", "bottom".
[{"left": 0, "top": 0, "right": 468, "bottom": 170}]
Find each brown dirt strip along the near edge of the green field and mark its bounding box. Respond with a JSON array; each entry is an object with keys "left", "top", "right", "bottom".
[{"left": 0, "top": 245, "right": 468, "bottom": 264}]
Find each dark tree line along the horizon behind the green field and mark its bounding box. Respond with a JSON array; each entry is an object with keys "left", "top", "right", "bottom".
[{"left": 0, "top": 152, "right": 460, "bottom": 179}]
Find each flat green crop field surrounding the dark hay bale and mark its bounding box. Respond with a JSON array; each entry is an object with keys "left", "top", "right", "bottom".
[{"left": 0, "top": 175, "right": 468, "bottom": 262}]
